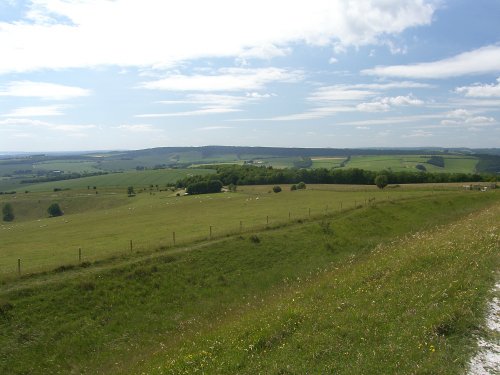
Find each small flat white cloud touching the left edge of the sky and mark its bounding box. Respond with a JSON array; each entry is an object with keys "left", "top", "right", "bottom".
[{"left": 0, "top": 81, "right": 90, "bottom": 100}]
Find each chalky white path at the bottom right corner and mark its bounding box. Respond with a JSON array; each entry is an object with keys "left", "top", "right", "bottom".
[{"left": 469, "top": 282, "right": 500, "bottom": 375}]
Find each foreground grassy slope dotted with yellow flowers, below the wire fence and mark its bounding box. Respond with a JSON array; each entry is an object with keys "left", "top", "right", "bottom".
[{"left": 0, "top": 193, "right": 499, "bottom": 374}]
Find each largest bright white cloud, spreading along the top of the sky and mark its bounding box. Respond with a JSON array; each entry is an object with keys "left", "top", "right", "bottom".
[{"left": 0, "top": 0, "right": 435, "bottom": 73}]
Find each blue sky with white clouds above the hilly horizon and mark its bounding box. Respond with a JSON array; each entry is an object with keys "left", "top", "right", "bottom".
[{"left": 0, "top": 0, "right": 500, "bottom": 153}]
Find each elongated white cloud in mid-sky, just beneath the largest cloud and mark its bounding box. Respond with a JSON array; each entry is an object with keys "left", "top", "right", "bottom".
[{"left": 140, "top": 68, "right": 303, "bottom": 92}]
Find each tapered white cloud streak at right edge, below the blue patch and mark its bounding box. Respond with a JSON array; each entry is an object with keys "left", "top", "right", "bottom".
[{"left": 362, "top": 45, "right": 500, "bottom": 79}]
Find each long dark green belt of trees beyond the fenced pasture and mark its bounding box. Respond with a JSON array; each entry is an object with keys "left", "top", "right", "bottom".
[{"left": 176, "top": 165, "right": 492, "bottom": 188}]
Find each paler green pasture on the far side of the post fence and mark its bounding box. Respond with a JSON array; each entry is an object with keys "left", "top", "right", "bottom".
[{"left": 0, "top": 185, "right": 453, "bottom": 275}]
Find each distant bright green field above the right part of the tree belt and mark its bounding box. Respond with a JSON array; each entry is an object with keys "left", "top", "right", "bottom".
[{"left": 345, "top": 155, "right": 479, "bottom": 173}]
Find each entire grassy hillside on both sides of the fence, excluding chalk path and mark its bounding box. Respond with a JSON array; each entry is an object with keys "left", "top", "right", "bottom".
[{"left": 0, "top": 185, "right": 500, "bottom": 374}]
